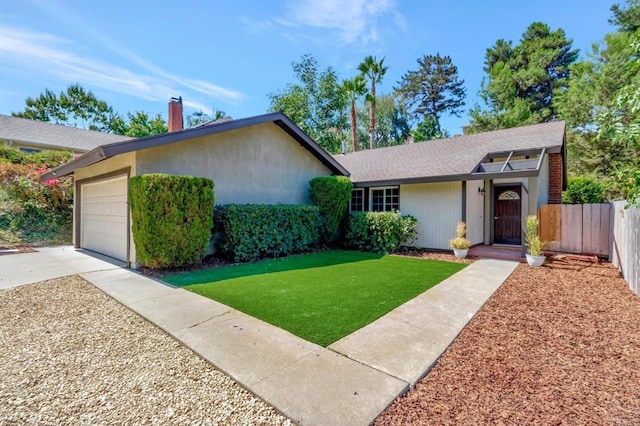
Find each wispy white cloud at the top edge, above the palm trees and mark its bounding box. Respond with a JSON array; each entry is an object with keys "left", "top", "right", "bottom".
[{"left": 272, "top": 0, "right": 404, "bottom": 44}]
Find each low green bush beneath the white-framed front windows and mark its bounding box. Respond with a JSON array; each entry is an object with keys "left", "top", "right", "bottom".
[{"left": 345, "top": 212, "right": 418, "bottom": 253}]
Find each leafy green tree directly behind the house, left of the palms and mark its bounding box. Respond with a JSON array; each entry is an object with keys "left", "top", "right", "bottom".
[{"left": 268, "top": 55, "right": 348, "bottom": 154}]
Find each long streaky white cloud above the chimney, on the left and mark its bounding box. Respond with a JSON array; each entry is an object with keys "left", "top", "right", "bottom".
[{"left": 0, "top": 26, "right": 244, "bottom": 110}]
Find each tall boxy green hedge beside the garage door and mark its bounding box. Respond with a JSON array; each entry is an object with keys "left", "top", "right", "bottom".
[{"left": 129, "top": 174, "right": 214, "bottom": 268}]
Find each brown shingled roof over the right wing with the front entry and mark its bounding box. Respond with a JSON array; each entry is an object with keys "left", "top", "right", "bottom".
[{"left": 334, "top": 121, "right": 565, "bottom": 186}]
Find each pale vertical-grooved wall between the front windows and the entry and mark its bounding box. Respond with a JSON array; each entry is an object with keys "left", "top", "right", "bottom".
[{"left": 400, "top": 182, "right": 462, "bottom": 250}]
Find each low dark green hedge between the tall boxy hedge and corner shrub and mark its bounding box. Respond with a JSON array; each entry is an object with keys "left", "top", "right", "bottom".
[{"left": 214, "top": 204, "right": 320, "bottom": 262}]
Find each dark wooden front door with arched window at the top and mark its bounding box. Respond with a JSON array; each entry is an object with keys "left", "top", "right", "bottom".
[{"left": 493, "top": 185, "right": 522, "bottom": 245}]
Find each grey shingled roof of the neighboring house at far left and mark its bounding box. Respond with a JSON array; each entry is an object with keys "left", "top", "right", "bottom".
[{"left": 0, "top": 114, "right": 131, "bottom": 152}]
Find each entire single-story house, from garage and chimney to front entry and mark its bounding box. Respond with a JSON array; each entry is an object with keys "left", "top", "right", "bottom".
[{"left": 43, "top": 94, "right": 566, "bottom": 266}]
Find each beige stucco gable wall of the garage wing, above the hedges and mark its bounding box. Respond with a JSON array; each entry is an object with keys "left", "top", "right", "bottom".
[{"left": 136, "top": 123, "right": 331, "bottom": 204}]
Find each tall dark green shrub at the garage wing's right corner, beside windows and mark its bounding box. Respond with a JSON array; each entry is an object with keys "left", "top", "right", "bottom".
[{"left": 309, "top": 176, "right": 353, "bottom": 242}]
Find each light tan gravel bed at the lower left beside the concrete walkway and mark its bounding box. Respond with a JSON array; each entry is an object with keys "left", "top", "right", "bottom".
[{"left": 0, "top": 276, "right": 291, "bottom": 425}]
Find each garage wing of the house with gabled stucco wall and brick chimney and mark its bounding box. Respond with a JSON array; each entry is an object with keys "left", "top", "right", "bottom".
[{"left": 42, "top": 100, "right": 349, "bottom": 267}]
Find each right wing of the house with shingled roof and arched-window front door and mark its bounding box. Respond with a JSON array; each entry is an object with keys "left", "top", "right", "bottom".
[{"left": 334, "top": 121, "right": 566, "bottom": 250}]
